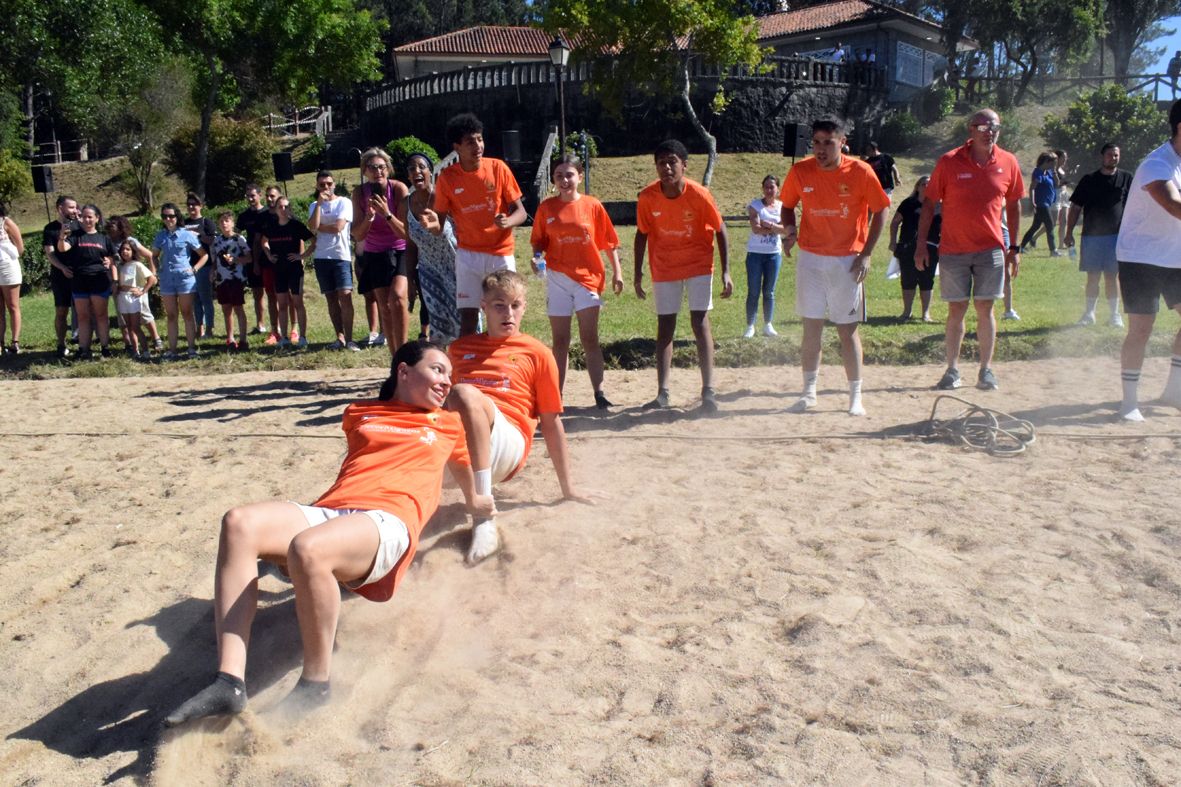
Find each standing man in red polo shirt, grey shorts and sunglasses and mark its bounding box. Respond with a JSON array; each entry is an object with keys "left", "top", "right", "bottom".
[{"left": 914, "top": 109, "right": 1025, "bottom": 391}]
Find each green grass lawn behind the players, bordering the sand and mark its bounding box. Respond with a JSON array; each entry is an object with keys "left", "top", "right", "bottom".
[{"left": 0, "top": 221, "right": 1181, "bottom": 378}]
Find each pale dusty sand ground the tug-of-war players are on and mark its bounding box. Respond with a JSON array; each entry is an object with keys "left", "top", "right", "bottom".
[{"left": 0, "top": 358, "right": 1181, "bottom": 785}]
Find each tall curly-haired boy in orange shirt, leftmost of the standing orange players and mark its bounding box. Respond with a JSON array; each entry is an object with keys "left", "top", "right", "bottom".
[{"left": 422, "top": 112, "right": 529, "bottom": 336}]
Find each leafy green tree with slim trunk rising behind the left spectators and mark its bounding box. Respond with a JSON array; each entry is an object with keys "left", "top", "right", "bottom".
[{"left": 142, "top": 0, "right": 384, "bottom": 195}]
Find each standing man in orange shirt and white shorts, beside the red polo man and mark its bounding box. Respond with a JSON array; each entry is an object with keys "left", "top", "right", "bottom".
[{"left": 779, "top": 118, "right": 889, "bottom": 416}]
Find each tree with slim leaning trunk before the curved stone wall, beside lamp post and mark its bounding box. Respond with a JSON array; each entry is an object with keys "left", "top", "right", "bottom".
[{"left": 543, "top": 0, "right": 763, "bottom": 186}]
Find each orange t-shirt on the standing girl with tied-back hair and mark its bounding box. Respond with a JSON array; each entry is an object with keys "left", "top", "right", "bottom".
[{"left": 529, "top": 194, "right": 619, "bottom": 292}]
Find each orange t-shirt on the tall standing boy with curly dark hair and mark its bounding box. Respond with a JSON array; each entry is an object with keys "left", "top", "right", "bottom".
[{"left": 435, "top": 157, "right": 521, "bottom": 254}]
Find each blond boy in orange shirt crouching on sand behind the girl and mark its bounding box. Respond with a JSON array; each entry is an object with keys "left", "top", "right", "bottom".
[{"left": 446, "top": 271, "right": 591, "bottom": 564}]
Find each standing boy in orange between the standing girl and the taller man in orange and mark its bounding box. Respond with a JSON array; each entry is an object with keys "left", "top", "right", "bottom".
[{"left": 634, "top": 139, "right": 733, "bottom": 412}]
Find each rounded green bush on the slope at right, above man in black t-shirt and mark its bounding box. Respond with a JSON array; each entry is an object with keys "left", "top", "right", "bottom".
[{"left": 1042, "top": 84, "right": 1169, "bottom": 168}]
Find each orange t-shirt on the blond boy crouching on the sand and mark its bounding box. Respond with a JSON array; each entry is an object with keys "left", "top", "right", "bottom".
[{"left": 446, "top": 333, "right": 562, "bottom": 477}]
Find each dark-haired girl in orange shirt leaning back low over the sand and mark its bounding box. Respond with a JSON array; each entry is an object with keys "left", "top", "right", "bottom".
[{"left": 164, "top": 342, "right": 492, "bottom": 727}]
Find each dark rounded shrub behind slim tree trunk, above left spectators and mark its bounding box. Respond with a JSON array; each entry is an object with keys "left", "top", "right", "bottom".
[{"left": 164, "top": 115, "right": 272, "bottom": 204}]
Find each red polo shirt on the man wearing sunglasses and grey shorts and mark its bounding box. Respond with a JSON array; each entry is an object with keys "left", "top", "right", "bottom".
[{"left": 926, "top": 142, "right": 1025, "bottom": 254}]
